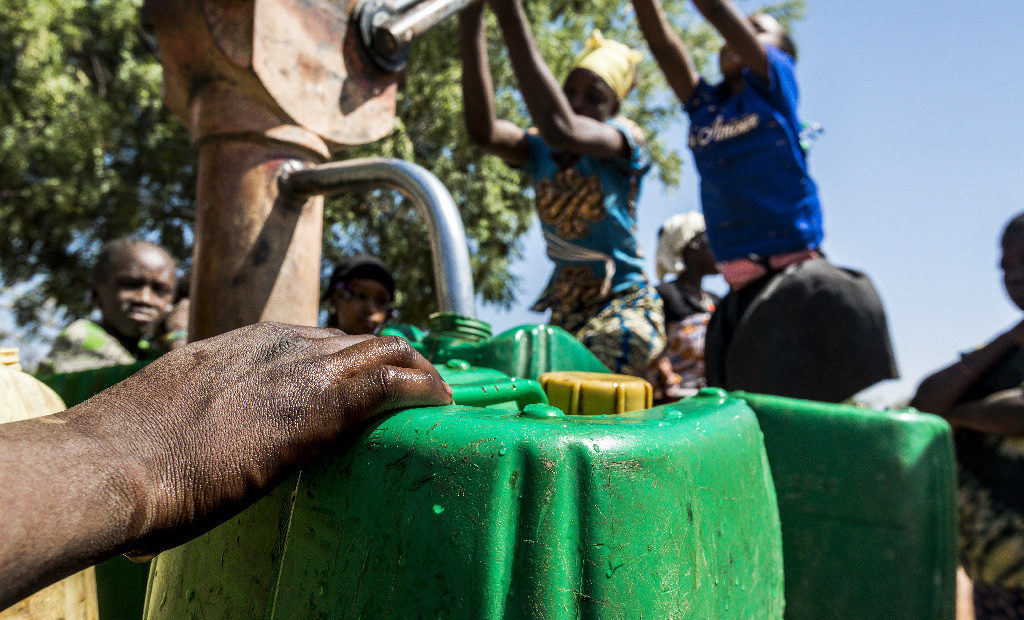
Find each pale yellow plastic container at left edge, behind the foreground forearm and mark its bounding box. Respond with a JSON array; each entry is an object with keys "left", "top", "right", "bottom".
[{"left": 0, "top": 348, "right": 99, "bottom": 620}]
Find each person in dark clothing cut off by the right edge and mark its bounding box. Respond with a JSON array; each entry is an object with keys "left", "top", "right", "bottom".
[{"left": 910, "top": 213, "right": 1024, "bottom": 620}]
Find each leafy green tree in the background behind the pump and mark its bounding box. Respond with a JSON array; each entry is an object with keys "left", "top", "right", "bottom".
[{"left": 0, "top": 0, "right": 803, "bottom": 338}]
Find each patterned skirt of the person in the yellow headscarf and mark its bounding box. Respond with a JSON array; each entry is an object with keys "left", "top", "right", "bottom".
[{"left": 550, "top": 286, "right": 665, "bottom": 377}]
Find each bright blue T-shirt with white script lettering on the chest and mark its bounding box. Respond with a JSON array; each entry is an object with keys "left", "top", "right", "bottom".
[{"left": 686, "top": 46, "right": 823, "bottom": 261}]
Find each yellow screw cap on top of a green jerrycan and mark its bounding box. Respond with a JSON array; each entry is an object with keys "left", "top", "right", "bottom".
[{"left": 541, "top": 371, "right": 654, "bottom": 415}]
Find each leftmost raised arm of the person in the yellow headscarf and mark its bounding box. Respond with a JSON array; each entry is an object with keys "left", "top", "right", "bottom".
[{"left": 459, "top": 1, "right": 529, "bottom": 167}]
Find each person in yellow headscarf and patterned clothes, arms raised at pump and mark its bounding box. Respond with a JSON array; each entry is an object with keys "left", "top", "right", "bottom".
[{"left": 461, "top": 0, "right": 665, "bottom": 376}]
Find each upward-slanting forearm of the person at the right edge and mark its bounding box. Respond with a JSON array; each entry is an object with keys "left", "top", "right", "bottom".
[{"left": 910, "top": 332, "right": 1015, "bottom": 416}]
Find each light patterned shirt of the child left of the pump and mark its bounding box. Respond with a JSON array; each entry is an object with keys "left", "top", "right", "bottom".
[{"left": 39, "top": 319, "right": 157, "bottom": 374}]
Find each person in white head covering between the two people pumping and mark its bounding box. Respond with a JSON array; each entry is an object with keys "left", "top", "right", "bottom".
[{"left": 648, "top": 211, "right": 719, "bottom": 402}]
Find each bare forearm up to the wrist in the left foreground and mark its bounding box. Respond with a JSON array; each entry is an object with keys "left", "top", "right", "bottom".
[{"left": 0, "top": 404, "right": 138, "bottom": 609}]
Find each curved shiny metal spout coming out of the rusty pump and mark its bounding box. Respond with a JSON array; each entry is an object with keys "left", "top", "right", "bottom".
[{"left": 278, "top": 158, "right": 476, "bottom": 318}]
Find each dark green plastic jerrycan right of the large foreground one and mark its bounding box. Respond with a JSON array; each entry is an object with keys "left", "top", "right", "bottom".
[{"left": 732, "top": 392, "right": 956, "bottom": 620}]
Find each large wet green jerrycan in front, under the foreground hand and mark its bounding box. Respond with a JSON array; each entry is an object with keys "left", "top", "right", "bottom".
[{"left": 146, "top": 390, "right": 783, "bottom": 619}]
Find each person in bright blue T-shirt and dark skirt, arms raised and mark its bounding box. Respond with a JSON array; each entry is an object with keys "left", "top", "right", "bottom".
[{"left": 633, "top": 0, "right": 896, "bottom": 401}]
